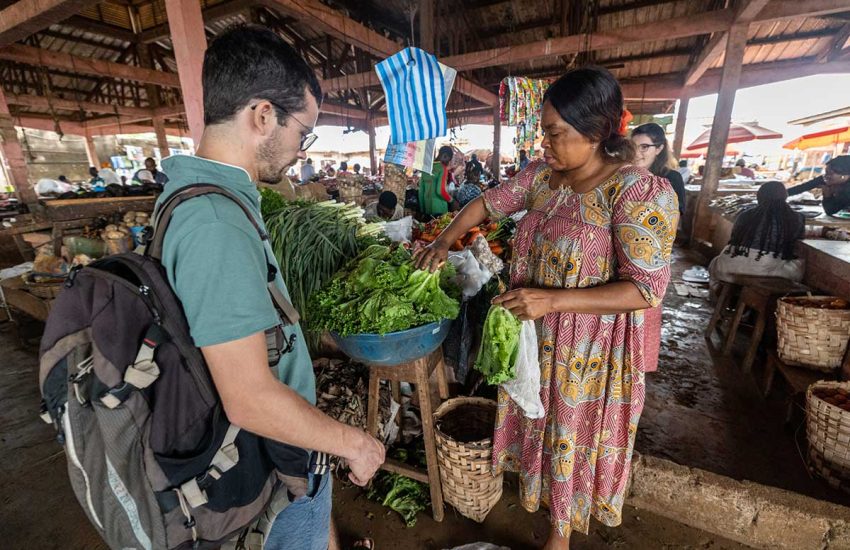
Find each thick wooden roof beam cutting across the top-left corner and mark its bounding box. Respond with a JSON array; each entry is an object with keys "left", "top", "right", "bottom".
[{"left": 0, "top": 0, "right": 96, "bottom": 47}]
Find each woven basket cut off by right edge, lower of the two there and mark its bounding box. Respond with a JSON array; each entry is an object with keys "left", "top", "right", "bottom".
[{"left": 806, "top": 380, "right": 850, "bottom": 479}]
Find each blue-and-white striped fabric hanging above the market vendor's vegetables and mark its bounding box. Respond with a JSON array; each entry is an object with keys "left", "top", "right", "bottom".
[{"left": 375, "top": 48, "right": 449, "bottom": 144}]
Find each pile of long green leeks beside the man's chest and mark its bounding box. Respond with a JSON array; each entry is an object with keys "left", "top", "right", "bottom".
[{"left": 261, "top": 197, "right": 383, "bottom": 319}]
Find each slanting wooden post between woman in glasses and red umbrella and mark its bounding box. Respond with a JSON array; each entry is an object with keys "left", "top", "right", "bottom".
[{"left": 691, "top": 23, "right": 749, "bottom": 244}]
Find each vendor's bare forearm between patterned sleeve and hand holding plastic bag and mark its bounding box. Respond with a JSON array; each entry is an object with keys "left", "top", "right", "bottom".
[{"left": 550, "top": 281, "right": 650, "bottom": 315}]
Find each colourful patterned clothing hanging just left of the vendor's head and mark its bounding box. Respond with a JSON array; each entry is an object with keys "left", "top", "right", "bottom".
[{"left": 499, "top": 76, "right": 549, "bottom": 155}]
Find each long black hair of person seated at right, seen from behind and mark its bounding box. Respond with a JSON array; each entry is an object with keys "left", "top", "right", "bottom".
[{"left": 729, "top": 181, "right": 805, "bottom": 260}]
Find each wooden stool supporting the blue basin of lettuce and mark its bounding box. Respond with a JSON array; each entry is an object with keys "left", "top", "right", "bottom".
[{"left": 367, "top": 348, "right": 449, "bottom": 521}]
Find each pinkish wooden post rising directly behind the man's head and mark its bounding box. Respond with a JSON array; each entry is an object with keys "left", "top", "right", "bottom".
[{"left": 165, "top": 0, "right": 207, "bottom": 148}]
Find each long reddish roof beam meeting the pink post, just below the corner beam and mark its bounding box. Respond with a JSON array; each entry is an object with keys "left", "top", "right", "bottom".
[{"left": 0, "top": 44, "right": 180, "bottom": 88}]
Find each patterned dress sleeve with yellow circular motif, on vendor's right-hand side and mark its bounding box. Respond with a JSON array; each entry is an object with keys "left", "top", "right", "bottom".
[{"left": 612, "top": 170, "right": 679, "bottom": 307}]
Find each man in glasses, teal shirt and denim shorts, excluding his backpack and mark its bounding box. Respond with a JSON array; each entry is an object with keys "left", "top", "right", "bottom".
[{"left": 158, "top": 26, "right": 384, "bottom": 550}]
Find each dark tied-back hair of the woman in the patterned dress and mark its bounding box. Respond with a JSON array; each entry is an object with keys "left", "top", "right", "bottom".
[{"left": 543, "top": 66, "right": 635, "bottom": 162}]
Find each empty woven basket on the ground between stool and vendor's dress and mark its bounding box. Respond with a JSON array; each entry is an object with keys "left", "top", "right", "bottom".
[{"left": 434, "top": 397, "right": 502, "bottom": 523}]
